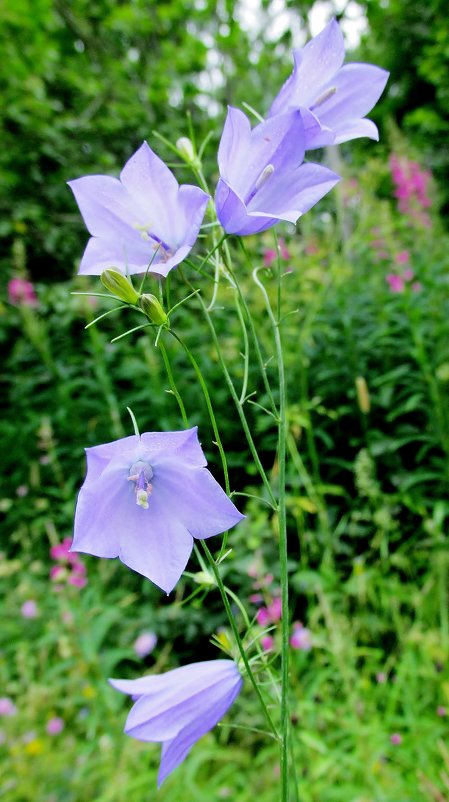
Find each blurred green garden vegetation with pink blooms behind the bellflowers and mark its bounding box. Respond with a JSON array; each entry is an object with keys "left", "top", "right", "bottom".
[{"left": 0, "top": 0, "right": 449, "bottom": 802}]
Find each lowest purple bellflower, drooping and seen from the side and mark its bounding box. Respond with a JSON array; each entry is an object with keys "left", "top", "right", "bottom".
[{"left": 109, "top": 660, "right": 242, "bottom": 787}]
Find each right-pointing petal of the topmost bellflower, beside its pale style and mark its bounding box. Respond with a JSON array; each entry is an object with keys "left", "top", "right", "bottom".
[{"left": 317, "top": 64, "right": 388, "bottom": 129}]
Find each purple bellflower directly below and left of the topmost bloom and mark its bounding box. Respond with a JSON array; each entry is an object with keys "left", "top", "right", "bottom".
[{"left": 215, "top": 107, "right": 339, "bottom": 235}]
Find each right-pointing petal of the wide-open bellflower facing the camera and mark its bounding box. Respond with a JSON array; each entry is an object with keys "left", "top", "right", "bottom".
[{"left": 156, "top": 459, "right": 245, "bottom": 539}]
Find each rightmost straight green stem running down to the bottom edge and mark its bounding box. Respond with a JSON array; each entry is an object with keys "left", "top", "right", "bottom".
[{"left": 253, "top": 269, "right": 290, "bottom": 802}]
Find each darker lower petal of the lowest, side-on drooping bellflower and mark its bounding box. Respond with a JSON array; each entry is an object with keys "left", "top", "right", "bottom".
[{"left": 158, "top": 677, "right": 242, "bottom": 788}]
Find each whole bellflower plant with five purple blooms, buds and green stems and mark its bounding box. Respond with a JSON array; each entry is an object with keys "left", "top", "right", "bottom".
[{"left": 70, "top": 15, "right": 387, "bottom": 802}]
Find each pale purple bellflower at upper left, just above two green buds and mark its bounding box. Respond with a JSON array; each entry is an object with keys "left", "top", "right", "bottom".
[{"left": 68, "top": 142, "right": 209, "bottom": 276}]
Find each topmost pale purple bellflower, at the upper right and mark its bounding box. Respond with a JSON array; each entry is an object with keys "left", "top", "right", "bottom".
[{"left": 269, "top": 19, "right": 388, "bottom": 150}]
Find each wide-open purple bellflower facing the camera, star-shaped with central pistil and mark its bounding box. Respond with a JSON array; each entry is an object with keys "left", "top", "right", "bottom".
[{"left": 72, "top": 427, "right": 244, "bottom": 593}]
